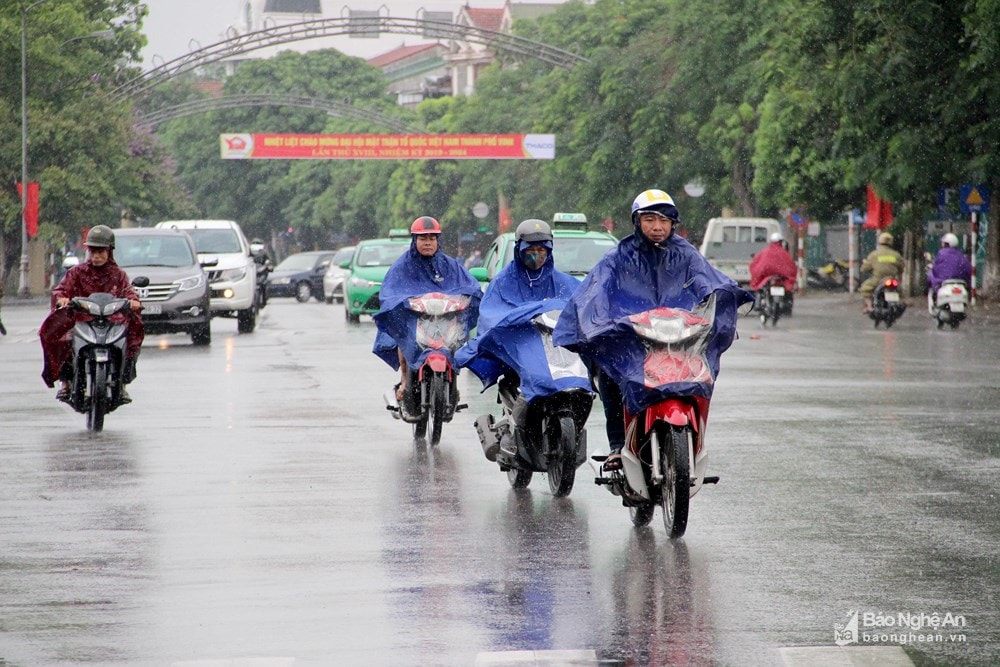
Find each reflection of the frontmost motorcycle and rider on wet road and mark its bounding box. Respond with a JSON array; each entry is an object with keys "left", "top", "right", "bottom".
[{"left": 599, "top": 528, "right": 713, "bottom": 667}]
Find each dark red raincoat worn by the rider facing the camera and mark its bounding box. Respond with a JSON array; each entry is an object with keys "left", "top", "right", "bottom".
[{"left": 38, "top": 258, "right": 145, "bottom": 387}]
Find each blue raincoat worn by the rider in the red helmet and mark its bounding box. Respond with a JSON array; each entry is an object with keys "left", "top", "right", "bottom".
[{"left": 372, "top": 238, "right": 483, "bottom": 370}]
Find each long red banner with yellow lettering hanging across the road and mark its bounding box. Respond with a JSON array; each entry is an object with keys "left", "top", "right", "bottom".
[{"left": 219, "top": 134, "right": 556, "bottom": 160}]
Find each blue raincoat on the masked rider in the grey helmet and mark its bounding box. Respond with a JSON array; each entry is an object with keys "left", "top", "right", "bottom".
[{"left": 455, "top": 242, "right": 591, "bottom": 402}]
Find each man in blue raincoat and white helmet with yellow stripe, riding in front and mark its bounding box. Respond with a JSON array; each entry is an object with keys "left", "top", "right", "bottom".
[{"left": 552, "top": 190, "right": 753, "bottom": 470}]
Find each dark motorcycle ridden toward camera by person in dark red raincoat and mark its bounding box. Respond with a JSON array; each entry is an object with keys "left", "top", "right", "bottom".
[{"left": 66, "top": 288, "right": 149, "bottom": 433}]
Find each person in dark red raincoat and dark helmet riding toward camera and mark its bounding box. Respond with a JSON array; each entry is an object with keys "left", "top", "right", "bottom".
[{"left": 38, "top": 225, "right": 145, "bottom": 402}]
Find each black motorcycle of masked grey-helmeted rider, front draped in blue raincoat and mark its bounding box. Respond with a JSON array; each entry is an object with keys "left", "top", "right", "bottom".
[{"left": 460, "top": 306, "right": 594, "bottom": 497}]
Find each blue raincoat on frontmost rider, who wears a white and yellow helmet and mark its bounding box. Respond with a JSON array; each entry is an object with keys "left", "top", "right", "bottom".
[{"left": 553, "top": 231, "right": 753, "bottom": 414}]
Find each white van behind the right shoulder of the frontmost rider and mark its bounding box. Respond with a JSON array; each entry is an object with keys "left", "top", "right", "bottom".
[{"left": 701, "top": 218, "right": 781, "bottom": 285}]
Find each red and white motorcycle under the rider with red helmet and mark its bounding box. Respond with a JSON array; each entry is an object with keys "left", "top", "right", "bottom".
[{"left": 384, "top": 292, "right": 471, "bottom": 446}]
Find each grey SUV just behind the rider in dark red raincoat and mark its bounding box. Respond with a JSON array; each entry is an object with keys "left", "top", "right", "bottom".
[{"left": 115, "top": 229, "right": 213, "bottom": 345}]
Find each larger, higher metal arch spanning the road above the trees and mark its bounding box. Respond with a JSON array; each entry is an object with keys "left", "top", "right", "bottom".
[{"left": 111, "top": 16, "right": 589, "bottom": 99}]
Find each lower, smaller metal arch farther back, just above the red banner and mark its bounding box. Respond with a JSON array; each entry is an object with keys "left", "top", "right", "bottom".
[{"left": 140, "top": 93, "right": 422, "bottom": 133}]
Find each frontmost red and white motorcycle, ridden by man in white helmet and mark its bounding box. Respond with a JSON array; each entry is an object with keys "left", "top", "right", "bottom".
[{"left": 591, "top": 294, "right": 732, "bottom": 538}]
